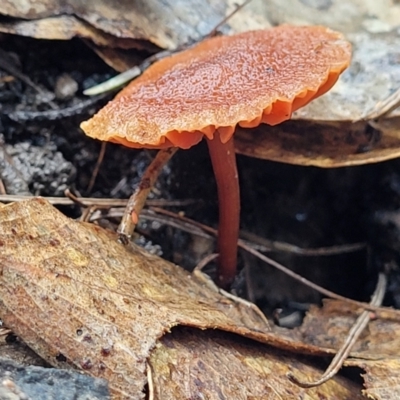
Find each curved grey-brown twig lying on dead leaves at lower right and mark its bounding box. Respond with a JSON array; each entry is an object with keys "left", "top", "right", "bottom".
[{"left": 288, "top": 273, "right": 387, "bottom": 388}]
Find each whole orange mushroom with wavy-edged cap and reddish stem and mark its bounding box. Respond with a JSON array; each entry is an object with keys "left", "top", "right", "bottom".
[{"left": 81, "top": 25, "right": 351, "bottom": 288}]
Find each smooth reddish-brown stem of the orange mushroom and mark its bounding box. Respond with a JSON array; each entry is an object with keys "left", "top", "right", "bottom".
[{"left": 207, "top": 131, "right": 240, "bottom": 288}]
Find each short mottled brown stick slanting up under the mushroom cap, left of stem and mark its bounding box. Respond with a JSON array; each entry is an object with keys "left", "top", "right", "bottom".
[{"left": 117, "top": 147, "right": 178, "bottom": 244}]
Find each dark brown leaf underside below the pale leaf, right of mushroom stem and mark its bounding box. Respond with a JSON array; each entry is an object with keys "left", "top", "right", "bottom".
[{"left": 235, "top": 118, "right": 400, "bottom": 168}]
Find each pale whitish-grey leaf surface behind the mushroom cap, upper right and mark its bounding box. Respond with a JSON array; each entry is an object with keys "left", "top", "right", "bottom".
[{"left": 250, "top": 0, "right": 400, "bottom": 121}]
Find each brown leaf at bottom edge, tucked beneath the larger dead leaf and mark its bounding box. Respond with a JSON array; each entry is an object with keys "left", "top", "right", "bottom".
[{"left": 149, "top": 329, "right": 364, "bottom": 400}]
